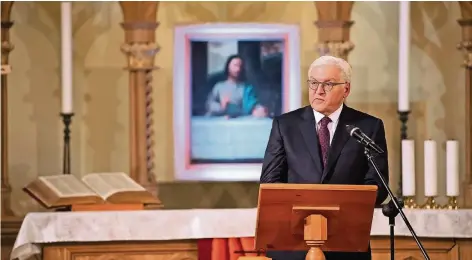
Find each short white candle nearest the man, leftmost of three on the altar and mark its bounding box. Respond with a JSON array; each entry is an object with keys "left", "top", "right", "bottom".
[{"left": 402, "top": 140, "right": 416, "bottom": 197}]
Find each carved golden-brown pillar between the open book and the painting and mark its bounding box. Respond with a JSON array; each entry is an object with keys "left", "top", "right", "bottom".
[{"left": 120, "top": 1, "right": 159, "bottom": 196}]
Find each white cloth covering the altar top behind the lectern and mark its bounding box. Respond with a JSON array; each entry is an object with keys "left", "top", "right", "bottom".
[{"left": 11, "top": 209, "right": 472, "bottom": 260}]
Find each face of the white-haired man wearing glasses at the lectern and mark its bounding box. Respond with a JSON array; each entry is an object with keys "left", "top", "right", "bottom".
[{"left": 308, "top": 65, "right": 350, "bottom": 115}]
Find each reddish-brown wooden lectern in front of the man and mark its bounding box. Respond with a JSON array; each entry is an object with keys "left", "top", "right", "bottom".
[{"left": 240, "top": 183, "right": 377, "bottom": 260}]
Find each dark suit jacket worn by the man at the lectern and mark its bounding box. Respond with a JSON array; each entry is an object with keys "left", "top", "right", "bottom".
[{"left": 260, "top": 105, "right": 388, "bottom": 260}]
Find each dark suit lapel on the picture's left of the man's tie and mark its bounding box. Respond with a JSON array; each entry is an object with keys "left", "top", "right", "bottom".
[{"left": 299, "top": 106, "right": 322, "bottom": 172}]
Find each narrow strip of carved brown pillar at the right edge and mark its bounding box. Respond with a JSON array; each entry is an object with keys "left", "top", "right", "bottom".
[{"left": 457, "top": 1, "right": 472, "bottom": 207}]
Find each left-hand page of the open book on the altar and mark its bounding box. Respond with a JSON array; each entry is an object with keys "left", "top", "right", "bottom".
[{"left": 38, "top": 174, "right": 97, "bottom": 198}]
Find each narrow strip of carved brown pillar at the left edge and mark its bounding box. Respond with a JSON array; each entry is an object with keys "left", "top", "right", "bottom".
[{"left": 1, "top": 1, "right": 14, "bottom": 218}]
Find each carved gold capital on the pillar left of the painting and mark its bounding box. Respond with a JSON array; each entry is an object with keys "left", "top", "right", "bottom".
[{"left": 121, "top": 42, "right": 159, "bottom": 70}]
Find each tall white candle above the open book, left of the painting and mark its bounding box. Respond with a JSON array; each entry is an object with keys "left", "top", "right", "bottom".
[{"left": 61, "top": 2, "right": 72, "bottom": 113}]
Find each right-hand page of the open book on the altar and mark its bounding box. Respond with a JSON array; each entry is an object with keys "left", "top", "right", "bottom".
[{"left": 82, "top": 172, "right": 146, "bottom": 200}]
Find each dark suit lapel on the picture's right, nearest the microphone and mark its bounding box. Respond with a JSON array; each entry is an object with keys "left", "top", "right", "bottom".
[{"left": 321, "top": 105, "right": 350, "bottom": 183}]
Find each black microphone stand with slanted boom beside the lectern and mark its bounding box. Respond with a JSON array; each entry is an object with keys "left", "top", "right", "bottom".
[{"left": 364, "top": 147, "right": 430, "bottom": 260}]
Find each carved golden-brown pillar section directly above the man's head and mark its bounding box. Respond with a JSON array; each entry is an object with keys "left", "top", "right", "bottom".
[{"left": 315, "top": 1, "right": 354, "bottom": 60}]
